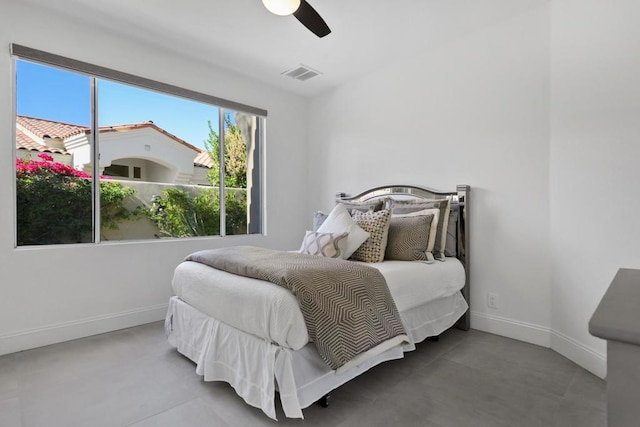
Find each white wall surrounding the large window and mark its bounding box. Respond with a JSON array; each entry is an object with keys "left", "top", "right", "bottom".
[{"left": 0, "top": 2, "right": 308, "bottom": 354}]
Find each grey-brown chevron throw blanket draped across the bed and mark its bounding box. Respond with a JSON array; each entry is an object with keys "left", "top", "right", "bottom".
[{"left": 186, "top": 246, "right": 408, "bottom": 369}]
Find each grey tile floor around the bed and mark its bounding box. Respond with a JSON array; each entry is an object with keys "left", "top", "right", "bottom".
[{"left": 0, "top": 322, "right": 606, "bottom": 427}]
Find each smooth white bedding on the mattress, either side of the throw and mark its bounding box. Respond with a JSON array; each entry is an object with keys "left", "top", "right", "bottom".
[{"left": 172, "top": 258, "right": 465, "bottom": 350}]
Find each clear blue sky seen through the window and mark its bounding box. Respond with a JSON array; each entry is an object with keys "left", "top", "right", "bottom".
[{"left": 16, "top": 60, "right": 218, "bottom": 148}]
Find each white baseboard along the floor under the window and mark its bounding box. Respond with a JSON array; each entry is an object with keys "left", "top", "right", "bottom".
[{"left": 0, "top": 304, "right": 168, "bottom": 355}]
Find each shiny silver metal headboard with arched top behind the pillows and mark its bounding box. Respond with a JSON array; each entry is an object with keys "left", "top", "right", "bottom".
[{"left": 336, "top": 185, "right": 471, "bottom": 330}]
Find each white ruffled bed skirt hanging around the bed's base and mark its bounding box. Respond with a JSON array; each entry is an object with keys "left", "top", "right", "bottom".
[{"left": 165, "top": 292, "right": 468, "bottom": 420}]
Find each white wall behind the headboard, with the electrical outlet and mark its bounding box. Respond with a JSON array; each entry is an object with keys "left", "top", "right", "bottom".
[{"left": 308, "top": 5, "right": 550, "bottom": 346}]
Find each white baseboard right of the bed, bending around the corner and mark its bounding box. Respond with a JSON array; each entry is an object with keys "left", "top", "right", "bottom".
[{"left": 471, "top": 311, "right": 607, "bottom": 378}]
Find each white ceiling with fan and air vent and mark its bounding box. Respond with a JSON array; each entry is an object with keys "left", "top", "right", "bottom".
[{"left": 22, "top": 0, "right": 549, "bottom": 96}]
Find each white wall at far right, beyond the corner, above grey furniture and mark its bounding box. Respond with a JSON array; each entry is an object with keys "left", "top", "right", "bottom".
[{"left": 550, "top": 0, "right": 640, "bottom": 375}]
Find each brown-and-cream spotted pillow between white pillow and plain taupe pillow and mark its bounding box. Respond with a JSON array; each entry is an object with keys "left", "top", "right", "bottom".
[{"left": 351, "top": 209, "right": 391, "bottom": 262}]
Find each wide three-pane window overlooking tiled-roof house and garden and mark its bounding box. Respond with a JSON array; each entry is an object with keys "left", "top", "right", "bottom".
[{"left": 12, "top": 45, "right": 266, "bottom": 246}]
